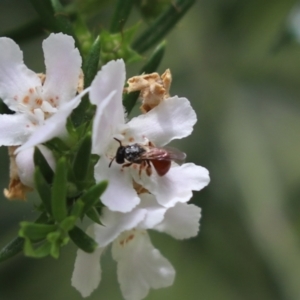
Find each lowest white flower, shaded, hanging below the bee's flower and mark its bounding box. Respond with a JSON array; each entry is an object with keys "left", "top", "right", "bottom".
[{"left": 72, "top": 194, "right": 200, "bottom": 300}]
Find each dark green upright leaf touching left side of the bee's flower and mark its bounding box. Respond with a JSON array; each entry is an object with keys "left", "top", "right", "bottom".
[{"left": 73, "top": 132, "right": 92, "bottom": 181}]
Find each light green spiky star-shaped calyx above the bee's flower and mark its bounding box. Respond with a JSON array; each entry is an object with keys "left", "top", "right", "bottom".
[{"left": 101, "top": 24, "right": 142, "bottom": 64}]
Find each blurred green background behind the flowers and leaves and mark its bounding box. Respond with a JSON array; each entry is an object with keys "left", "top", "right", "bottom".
[{"left": 0, "top": 0, "right": 300, "bottom": 300}]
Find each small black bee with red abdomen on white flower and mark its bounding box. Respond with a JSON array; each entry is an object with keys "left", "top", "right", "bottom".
[{"left": 109, "top": 138, "right": 186, "bottom": 176}]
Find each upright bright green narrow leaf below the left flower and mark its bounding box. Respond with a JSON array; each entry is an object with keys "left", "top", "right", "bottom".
[{"left": 51, "top": 157, "right": 68, "bottom": 222}]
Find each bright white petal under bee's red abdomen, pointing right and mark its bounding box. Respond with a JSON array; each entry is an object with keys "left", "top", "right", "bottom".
[{"left": 131, "top": 163, "right": 210, "bottom": 207}]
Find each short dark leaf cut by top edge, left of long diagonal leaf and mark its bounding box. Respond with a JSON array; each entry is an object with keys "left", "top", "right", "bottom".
[{"left": 110, "top": 0, "right": 135, "bottom": 33}]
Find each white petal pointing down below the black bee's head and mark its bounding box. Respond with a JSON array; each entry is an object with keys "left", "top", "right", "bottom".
[{"left": 95, "top": 156, "right": 140, "bottom": 213}]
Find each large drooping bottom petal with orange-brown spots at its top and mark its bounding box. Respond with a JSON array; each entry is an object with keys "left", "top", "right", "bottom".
[{"left": 112, "top": 231, "right": 175, "bottom": 300}]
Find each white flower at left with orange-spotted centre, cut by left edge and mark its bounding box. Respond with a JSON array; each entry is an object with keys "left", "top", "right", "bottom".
[{"left": 0, "top": 33, "right": 86, "bottom": 186}]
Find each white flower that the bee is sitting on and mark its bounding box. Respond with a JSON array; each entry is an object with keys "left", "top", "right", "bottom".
[{"left": 90, "top": 60, "right": 209, "bottom": 212}]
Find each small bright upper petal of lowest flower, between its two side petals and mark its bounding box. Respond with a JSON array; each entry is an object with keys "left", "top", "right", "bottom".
[{"left": 138, "top": 193, "right": 167, "bottom": 229}]
